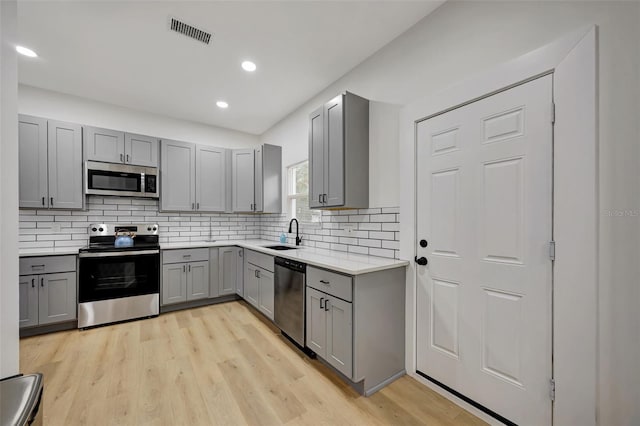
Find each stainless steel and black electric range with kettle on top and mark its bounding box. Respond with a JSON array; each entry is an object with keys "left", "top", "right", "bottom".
[{"left": 78, "top": 223, "right": 160, "bottom": 328}]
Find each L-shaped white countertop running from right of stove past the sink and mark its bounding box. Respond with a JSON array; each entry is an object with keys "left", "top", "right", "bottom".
[{"left": 160, "top": 240, "right": 409, "bottom": 275}]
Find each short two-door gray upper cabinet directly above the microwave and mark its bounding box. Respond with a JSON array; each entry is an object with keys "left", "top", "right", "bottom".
[{"left": 84, "top": 126, "right": 158, "bottom": 167}]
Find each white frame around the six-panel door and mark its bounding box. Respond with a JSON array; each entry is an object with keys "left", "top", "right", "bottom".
[{"left": 399, "top": 25, "right": 599, "bottom": 426}]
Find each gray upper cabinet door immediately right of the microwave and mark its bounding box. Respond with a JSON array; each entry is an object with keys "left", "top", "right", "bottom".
[{"left": 160, "top": 140, "right": 196, "bottom": 211}]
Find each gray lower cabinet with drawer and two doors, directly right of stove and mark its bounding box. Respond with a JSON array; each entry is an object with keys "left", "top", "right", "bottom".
[{"left": 162, "top": 248, "right": 210, "bottom": 305}]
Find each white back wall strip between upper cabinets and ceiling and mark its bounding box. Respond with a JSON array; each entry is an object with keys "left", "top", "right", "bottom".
[{"left": 18, "top": 84, "right": 259, "bottom": 148}]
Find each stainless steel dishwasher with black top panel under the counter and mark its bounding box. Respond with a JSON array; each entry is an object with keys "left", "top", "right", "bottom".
[{"left": 274, "top": 257, "right": 307, "bottom": 347}]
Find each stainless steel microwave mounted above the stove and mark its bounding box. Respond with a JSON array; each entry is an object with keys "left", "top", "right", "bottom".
[{"left": 84, "top": 161, "right": 159, "bottom": 198}]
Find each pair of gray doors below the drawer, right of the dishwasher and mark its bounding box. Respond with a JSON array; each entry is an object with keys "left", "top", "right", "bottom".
[{"left": 307, "top": 287, "right": 353, "bottom": 378}]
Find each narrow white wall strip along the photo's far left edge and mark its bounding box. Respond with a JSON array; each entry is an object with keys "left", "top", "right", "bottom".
[{"left": 0, "top": 0, "right": 19, "bottom": 378}]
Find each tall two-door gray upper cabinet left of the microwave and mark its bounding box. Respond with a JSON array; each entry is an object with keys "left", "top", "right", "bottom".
[{"left": 18, "top": 115, "right": 83, "bottom": 209}]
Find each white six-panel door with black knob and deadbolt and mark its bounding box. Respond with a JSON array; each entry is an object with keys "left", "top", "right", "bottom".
[{"left": 416, "top": 75, "right": 553, "bottom": 425}]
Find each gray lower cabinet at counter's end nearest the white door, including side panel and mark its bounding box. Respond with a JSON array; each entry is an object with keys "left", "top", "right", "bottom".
[{"left": 306, "top": 265, "right": 405, "bottom": 395}]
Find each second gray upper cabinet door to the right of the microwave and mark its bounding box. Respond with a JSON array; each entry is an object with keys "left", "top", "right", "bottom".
[{"left": 196, "top": 145, "right": 227, "bottom": 212}]
